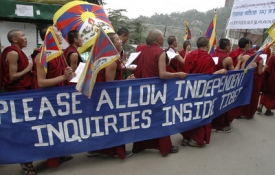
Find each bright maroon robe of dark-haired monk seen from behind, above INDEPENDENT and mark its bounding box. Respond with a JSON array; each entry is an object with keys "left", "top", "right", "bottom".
[{"left": 181, "top": 49, "right": 216, "bottom": 145}]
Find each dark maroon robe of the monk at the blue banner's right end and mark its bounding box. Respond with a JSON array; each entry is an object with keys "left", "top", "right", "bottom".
[{"left": 240, "top": 56, "right": 263, "bottom": 118}]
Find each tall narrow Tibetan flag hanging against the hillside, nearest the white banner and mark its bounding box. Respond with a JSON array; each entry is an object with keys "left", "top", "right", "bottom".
[{"left": 205, "top": 13, "right": 217, "bottom": 54}]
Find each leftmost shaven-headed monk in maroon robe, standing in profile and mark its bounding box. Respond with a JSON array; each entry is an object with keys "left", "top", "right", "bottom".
[{"left": 0, "top": 30, "right": 35, "bottom": 175}]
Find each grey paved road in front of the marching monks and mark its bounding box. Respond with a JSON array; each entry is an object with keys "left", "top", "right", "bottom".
[{"left": 0, "top": 110, "right": 275, "bottom": 175}]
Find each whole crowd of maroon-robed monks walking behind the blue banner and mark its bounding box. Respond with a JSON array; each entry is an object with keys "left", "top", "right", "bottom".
[{"left": 0, "top": 26, "right": 275, "bottom": 175}]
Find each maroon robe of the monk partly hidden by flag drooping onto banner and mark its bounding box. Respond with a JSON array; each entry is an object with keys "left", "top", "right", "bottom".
[{"left": 95, "top": 60, "right": 126, "bottom": 159}]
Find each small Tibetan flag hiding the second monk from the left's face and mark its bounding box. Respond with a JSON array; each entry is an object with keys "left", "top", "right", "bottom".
[{"left": 40, "top": 27, "right": 63, "bottom": 73}]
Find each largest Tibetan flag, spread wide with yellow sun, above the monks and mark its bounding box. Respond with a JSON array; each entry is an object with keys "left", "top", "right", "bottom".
[{"left": 53, "top": 1, "right": 114, "bottom": 54}]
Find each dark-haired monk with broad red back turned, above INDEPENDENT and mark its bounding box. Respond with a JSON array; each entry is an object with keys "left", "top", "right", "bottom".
[{"left": 181, "top": 37, "right": 227, "bottom": 147}]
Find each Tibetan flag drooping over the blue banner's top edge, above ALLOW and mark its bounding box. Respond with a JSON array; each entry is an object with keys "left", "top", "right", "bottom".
[{"left": 76, "top": 29, "right": 120, "bottom": 98}]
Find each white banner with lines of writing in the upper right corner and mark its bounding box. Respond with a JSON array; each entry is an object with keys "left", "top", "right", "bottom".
[{"left": 227, "top": 0, "right": 275, "bottom": 29}]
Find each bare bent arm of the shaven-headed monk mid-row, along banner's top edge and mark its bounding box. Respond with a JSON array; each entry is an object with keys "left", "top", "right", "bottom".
[{"left": 158, "top": 52, "right": 187, "bottom": 79}]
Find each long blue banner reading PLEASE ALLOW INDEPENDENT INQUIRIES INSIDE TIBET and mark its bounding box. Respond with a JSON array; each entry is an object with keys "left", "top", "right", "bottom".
[{"left": 0, "top": 69, "right": 254, "bottom": 164}]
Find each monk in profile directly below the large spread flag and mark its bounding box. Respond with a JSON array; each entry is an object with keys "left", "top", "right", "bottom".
[{"left": 64, "top": 30, "right": 83, "bottom": 72}]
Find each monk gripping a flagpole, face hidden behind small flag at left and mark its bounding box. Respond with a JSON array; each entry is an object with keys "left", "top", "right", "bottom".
[{"left": 35, "top": 26, "right": 74, "bottom": 167}]
